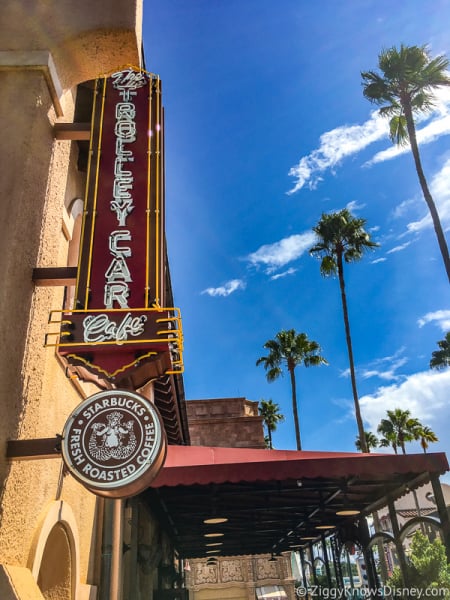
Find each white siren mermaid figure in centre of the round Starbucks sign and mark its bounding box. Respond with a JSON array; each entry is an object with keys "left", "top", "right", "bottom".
[{"left": 89, "top": 411, "right": 137, "bottom": 462}]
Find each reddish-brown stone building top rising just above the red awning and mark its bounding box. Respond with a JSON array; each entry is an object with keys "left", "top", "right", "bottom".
[{"left": 186, "top": 398, "right": 265, "bottom": 448}]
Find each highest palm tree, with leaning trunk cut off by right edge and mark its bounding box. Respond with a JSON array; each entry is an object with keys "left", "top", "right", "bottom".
[{"left": 361, "top": 44, "right": 450, "bottom": 281}]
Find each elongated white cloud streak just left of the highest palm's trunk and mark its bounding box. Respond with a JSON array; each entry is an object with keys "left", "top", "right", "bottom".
[{"left": 288, "top": 111, "right": 388, "bottom": 194}]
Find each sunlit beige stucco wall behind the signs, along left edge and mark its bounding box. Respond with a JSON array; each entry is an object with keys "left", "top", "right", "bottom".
[{"left": 0, "top": 0, "right": 142, "bottom": 600}]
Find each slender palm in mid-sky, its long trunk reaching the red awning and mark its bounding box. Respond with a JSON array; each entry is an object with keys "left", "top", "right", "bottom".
[{"left": 309, "top": 208, "right": 378, "bottom": 452}]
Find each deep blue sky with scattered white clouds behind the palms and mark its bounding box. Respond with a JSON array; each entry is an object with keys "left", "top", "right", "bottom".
[{"left": 144, "top": 0, "right": 450, "bottom": 464}]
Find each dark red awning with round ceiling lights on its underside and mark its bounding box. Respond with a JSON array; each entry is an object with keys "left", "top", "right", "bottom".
[{"left": 144, "top": 446, "right": 449, "bottom": 558}]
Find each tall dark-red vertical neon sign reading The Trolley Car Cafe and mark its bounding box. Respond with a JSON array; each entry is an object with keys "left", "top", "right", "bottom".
[{"left": 46, "top": 68, "right": 182, "bottom": 387}]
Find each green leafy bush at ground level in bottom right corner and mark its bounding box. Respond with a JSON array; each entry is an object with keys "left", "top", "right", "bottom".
[{"left": 387, "top": 531, "right": 450, "bottom": 598}]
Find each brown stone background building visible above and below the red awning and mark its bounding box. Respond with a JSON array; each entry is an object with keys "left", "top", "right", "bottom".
[{"left": 186, "top": 398, "right": 295, "bottom": 600}]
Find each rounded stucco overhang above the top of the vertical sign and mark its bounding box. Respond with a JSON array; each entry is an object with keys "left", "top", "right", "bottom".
[{"left": 0, "top": 0, "right": 142, "bottom": 89}]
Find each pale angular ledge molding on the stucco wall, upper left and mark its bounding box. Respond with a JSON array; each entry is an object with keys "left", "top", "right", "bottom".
[{"left": 0, "top": 50, "right": 64, "bottom": 117}]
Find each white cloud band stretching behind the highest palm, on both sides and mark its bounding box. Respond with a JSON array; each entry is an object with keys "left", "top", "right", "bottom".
[{"left": 288, "top": 88, "right": 450, "bottom": 194}]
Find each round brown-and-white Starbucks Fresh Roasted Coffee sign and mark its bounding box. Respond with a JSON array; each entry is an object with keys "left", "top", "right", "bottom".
[{"left": 62, "top": 390, "right": 167, "bottom": 498}]
